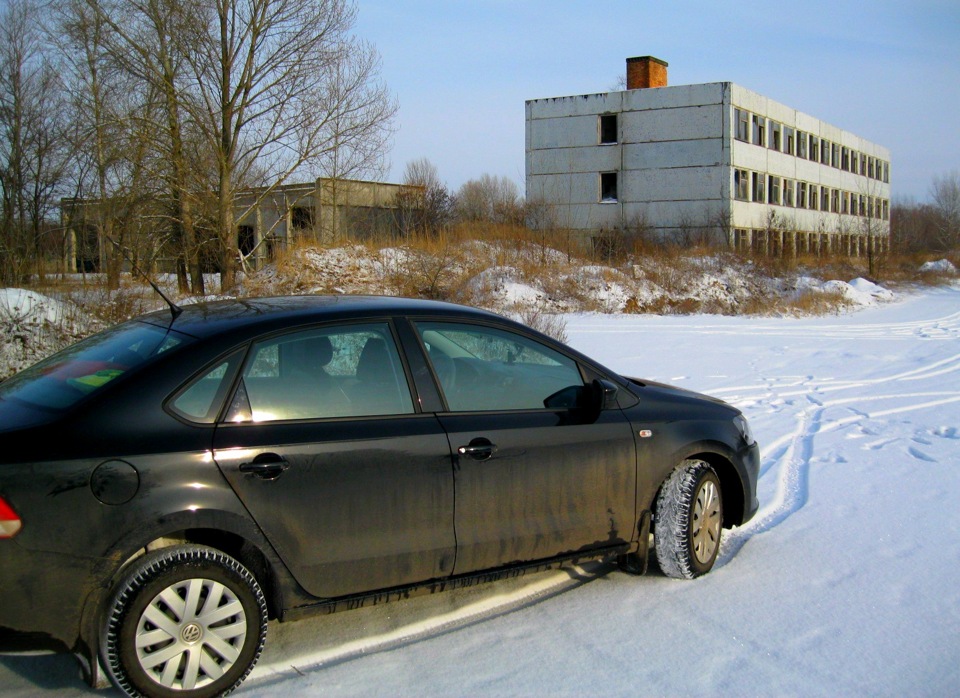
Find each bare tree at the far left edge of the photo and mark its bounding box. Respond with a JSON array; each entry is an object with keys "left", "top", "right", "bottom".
[{"left": 0, "top": 0, "right": 68, "bottom": 282}]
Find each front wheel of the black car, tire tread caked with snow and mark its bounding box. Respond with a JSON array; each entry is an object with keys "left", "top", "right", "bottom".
[{"left": 653, "top": 460, "right": 723, "bottom": 579}]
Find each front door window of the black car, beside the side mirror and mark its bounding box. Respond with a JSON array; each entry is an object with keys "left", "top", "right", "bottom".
[{"left": 417, "top": 322, "right": 584, "bottom": 412}]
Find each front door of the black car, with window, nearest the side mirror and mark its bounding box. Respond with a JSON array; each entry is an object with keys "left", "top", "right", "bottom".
[{"left": 416, "top": 321, "right": 637, "bottom": 574}]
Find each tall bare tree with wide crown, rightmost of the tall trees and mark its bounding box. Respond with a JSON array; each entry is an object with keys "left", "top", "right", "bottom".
[{"left": 181, "top": 0, "right": 396, "bottom": 289}]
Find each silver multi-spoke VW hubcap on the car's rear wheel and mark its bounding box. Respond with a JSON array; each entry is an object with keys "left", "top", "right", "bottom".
[{"left": 136, "top": 579, "right": 247, "bottom": 691}]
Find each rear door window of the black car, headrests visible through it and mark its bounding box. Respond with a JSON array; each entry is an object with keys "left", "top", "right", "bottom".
[{"left": 226, "top": 323, "right": 414, "bottom": 422}]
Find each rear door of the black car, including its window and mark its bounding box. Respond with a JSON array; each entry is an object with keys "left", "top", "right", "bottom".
[{"left": 208, "top": 322, "right": 455, "bottom": 598}]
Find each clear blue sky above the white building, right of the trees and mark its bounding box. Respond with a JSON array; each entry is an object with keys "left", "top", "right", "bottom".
[{"left": 355, "top": 0, "right": 960, "bottom": 201}]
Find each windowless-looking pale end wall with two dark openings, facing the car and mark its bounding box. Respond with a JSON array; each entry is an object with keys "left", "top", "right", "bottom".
[{"left": 526, "top": 83, "right": 727, "bottom": 235}]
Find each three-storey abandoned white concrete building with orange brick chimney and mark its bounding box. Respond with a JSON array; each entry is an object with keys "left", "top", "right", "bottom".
[{"left": 526, "top": 56, "right": 890, "bottom": 256}]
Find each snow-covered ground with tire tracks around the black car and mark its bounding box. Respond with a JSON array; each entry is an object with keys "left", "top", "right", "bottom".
[{"left": 0, "top": 286, "right": 960, "bottom": 698}]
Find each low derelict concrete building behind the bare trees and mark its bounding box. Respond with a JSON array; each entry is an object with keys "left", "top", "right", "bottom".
[{"left": 61, "top": 178, "right": 417, "bottom": 272}]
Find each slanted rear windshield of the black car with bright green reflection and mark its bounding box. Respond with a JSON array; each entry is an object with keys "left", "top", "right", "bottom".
[{"left": 0, "top": 322, "right": 191, "bottom": 411}]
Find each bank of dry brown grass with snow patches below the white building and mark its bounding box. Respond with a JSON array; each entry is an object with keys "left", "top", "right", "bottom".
[{"left": 246, "top": 223, "right": 948, "bottom": 315}]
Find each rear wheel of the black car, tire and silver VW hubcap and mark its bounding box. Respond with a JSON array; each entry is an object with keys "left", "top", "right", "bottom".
[{"left": 100, "top": 545, "right": 267, "bottom": 698}]
